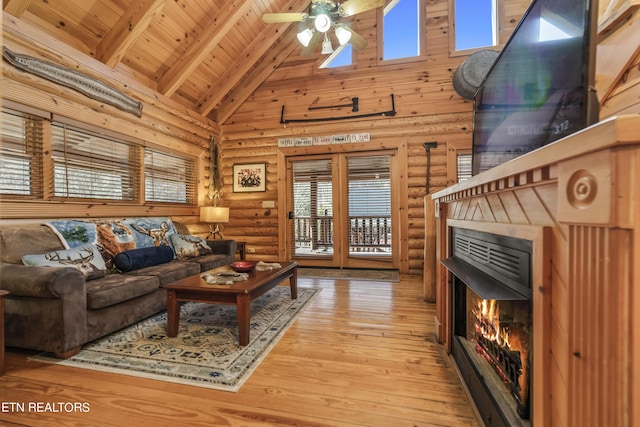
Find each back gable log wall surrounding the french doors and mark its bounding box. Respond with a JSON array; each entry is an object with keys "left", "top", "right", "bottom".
[{"left": 222, "top": 0, "right": 529, "bottom": 274}]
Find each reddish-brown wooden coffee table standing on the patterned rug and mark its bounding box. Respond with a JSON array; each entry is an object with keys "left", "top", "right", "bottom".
[{"left": 163, "top": 262, "right": 298, "bottom": 346}]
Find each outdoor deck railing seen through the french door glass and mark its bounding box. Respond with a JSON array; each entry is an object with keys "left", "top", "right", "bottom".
[{"left": 294, "top": 216, "right": 391, "bottom": 252}]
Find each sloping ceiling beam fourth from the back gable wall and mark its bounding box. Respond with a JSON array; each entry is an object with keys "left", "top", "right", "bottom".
[{"left": 96, "top": 0, "right": 166, "bottom": 67}]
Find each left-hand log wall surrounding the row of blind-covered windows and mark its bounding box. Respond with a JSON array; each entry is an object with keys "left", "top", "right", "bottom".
[{"left": 1, "top": 12, "right": 221, "bottom": 227}]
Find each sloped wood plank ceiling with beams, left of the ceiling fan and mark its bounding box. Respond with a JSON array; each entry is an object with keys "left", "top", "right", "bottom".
[{"left": 3, "top": 0, "right": 319, "bottom": 124}]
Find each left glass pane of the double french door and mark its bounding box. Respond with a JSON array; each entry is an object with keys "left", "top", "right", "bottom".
[{"left": 291, "top": 159, "right": 333, "bottom": 257}]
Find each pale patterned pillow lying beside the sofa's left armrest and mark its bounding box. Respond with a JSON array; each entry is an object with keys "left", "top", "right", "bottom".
[{"left": 22, "top": 244, "right": 107, "bottom": 280}]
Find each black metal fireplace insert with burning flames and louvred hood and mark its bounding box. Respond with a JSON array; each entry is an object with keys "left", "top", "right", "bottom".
[{"left": 442, "top": 228, "right": 533, "bottom": 426}]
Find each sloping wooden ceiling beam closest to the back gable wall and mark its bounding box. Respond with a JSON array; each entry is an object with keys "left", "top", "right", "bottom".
[{"left": 215, "top": 27, "right": 300, "bottom": 125}]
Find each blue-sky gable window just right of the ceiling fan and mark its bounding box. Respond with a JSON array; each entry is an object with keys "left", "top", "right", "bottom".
[{"left": 382, "top": 0, "right": 421, "bottom": 60}]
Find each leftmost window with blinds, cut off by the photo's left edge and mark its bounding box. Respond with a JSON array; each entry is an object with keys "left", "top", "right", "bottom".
[{"left": 0, "top": 108, "right": 44, "bottom": 197}]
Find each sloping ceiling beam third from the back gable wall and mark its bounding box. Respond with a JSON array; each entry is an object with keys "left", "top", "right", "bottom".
[{"left": 158, "top": 0, "right": 253, "bottom": 96}]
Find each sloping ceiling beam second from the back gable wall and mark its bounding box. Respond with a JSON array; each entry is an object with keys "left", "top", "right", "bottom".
[{"left": 198, "top": 0, "right": 309, "bottom": 116}]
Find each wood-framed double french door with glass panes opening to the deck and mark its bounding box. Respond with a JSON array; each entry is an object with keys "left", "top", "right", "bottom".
[{"left": 287, "top": 151, "right": 398, "bottom": 268}]
